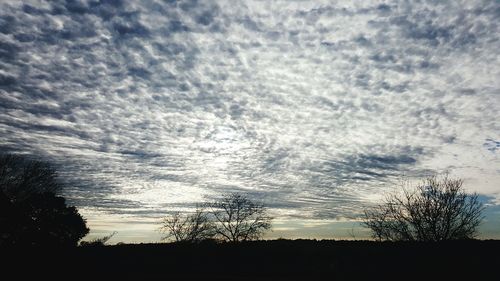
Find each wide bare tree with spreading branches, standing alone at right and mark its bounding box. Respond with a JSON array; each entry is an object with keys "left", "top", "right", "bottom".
[{"left": 363, "top": 176, "right": 484, "bottom": 241}]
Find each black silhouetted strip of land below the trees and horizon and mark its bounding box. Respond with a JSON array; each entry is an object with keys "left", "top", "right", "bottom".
[{"left": 0, "top": 240, "right": 500, "bottom": 280}]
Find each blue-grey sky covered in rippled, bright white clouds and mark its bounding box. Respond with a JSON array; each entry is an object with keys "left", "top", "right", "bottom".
[{"left": 0, "top": 0, "right": 500, "bottom": 242}]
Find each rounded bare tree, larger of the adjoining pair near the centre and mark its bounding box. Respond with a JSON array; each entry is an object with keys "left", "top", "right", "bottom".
[{"left": 207, "top": 193, "right": 272, "bottom": 242}]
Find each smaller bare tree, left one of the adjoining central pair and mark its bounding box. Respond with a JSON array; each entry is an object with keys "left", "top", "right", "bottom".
[{"left": 160, "top": 208, "right": 215, "bottom": 242}]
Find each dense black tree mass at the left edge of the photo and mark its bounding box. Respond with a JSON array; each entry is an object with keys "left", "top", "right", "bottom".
[{"left": 0, "top": 152, "right": 89, "bottom": 246}]
